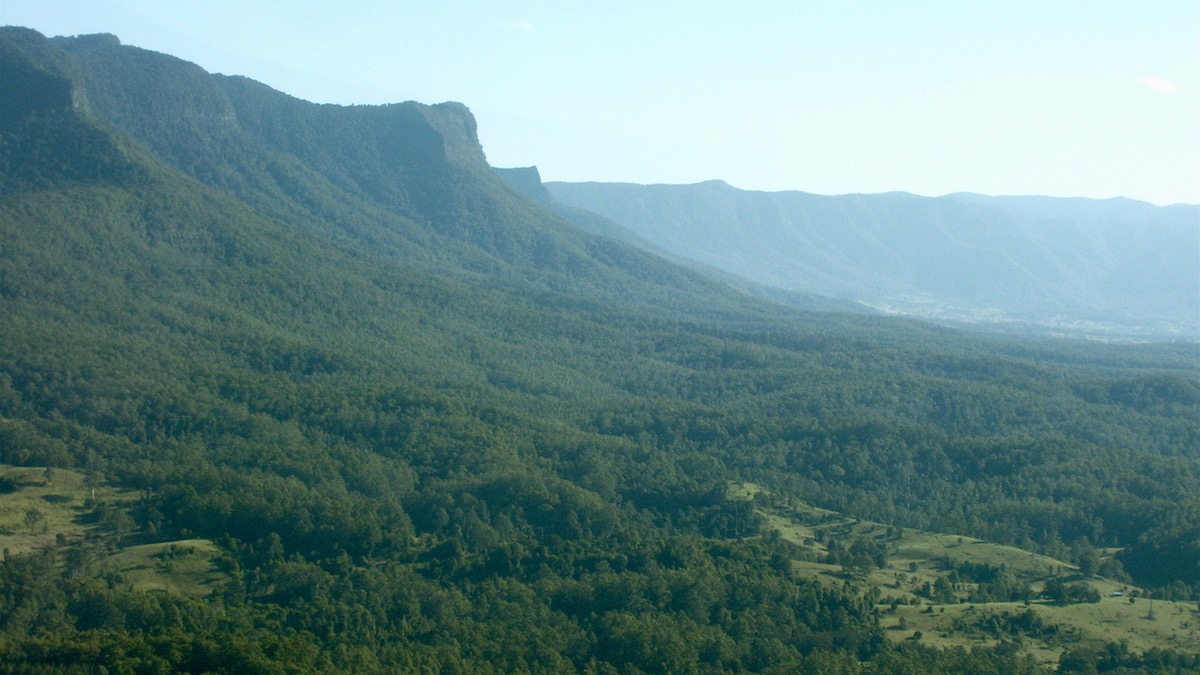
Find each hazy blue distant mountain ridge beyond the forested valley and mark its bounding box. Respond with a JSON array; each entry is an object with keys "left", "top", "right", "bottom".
[{"left": 545, "top": 181, "right": 1200, "bottom": 340}]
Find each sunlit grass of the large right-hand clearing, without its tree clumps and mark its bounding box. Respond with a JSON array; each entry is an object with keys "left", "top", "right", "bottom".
[{"left": 731, "top": 485, "right": 1200, "bottom": 665}]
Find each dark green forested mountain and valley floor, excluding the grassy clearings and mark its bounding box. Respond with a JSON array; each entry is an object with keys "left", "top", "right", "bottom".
[{"left": 0, "top": 28, "right": 1200, "bottom": 673}]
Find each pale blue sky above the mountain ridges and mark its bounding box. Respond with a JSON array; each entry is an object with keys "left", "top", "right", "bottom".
[{"left": 7, "top": 0, "right": 1200, "bottom": 204}]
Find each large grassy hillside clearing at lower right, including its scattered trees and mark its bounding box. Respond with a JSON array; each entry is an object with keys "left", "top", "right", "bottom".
[{"left": 732, "top": 484, "right": 1200, "bottom": 670}]
